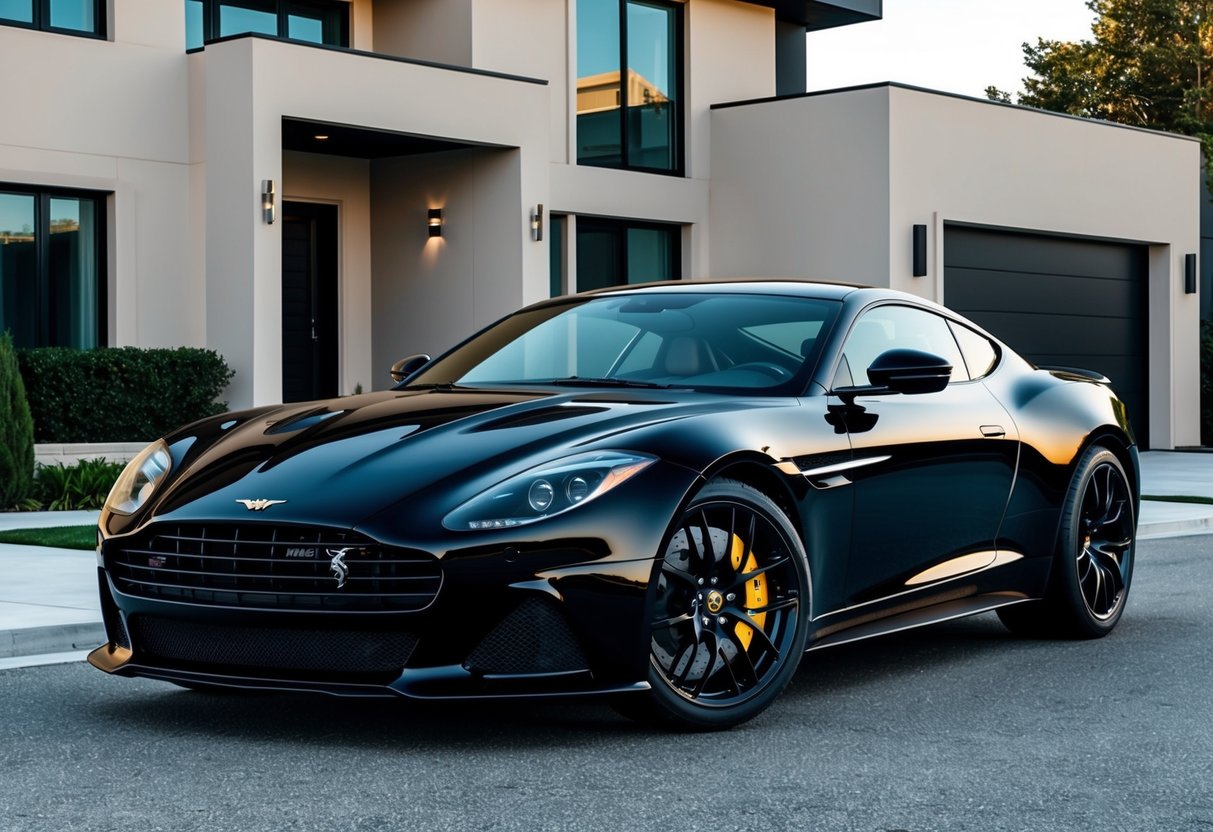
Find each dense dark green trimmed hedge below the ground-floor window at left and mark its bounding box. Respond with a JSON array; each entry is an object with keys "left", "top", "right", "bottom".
[{"left": 18, "top": 347, "right": 235, "bottom": 443}]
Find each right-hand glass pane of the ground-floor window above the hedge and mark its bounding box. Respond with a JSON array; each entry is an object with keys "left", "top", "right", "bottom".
[{"left": 50, "top": 199, "right": 98, "bottom": 348}]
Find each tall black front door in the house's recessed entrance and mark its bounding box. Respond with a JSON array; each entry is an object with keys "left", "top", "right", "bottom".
[{"left": 283, "top": 203, "right": 337, "bottom": 401}]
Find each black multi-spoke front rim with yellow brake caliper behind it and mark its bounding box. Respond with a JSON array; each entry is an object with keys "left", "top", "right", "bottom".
[{"left": 650, "top": 501, "right": 803, "bottom": 707}]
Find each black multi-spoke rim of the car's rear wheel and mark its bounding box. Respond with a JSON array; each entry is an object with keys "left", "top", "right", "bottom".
[{"left": 1075, "top": 462, "right": 1133, "bottom": 621}]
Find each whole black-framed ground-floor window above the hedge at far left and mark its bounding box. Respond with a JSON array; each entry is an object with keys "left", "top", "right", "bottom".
[{"left": 0, "top": 184, "right": 106, "bottom": 348}]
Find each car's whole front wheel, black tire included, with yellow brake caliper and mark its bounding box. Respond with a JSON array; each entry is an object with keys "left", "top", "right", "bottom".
[{"left": 615, "top": 479, "right": 810, "bottom": 730}]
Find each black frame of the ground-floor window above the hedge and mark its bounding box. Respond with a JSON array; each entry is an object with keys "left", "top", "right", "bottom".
[{"left": 0, "top": 182, "right": 110, "bottom": 348}]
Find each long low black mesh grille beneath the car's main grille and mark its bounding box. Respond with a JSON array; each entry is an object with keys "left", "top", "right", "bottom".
[{"left": 131, "top": 615, "right": 417, "bottom": 674}]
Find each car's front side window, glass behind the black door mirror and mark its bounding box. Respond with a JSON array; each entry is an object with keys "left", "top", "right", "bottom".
[{"left": 843, "top": 306, "right": 969, "bottom": 384}]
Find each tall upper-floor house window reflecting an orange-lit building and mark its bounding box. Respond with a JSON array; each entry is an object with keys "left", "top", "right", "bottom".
[{"left": 577, "top": 0, "right": 683, "bottom": 175}]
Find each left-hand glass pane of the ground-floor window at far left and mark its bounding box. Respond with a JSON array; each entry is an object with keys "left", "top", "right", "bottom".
[{"left": 0, "top": 193, "right": 38, "bottom": 347}]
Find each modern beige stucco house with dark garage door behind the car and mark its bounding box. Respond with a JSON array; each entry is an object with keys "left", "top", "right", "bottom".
[{"left": 0, "top": 0, "right": 1201, "bottom": 448}]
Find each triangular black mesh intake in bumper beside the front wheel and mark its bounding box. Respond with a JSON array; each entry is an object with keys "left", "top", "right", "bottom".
[{"left": 463, "top": 598, "right": 588, "bottom": 676}]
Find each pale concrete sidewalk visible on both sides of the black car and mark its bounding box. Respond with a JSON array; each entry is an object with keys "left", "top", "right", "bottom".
[{"left": 0, "top": 451, "right": 1213, "bottom": 669}]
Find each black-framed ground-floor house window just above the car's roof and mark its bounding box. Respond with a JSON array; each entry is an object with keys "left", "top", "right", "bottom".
[{"left": 577, "top": 217, "right": 682, "bottom": 292}]
